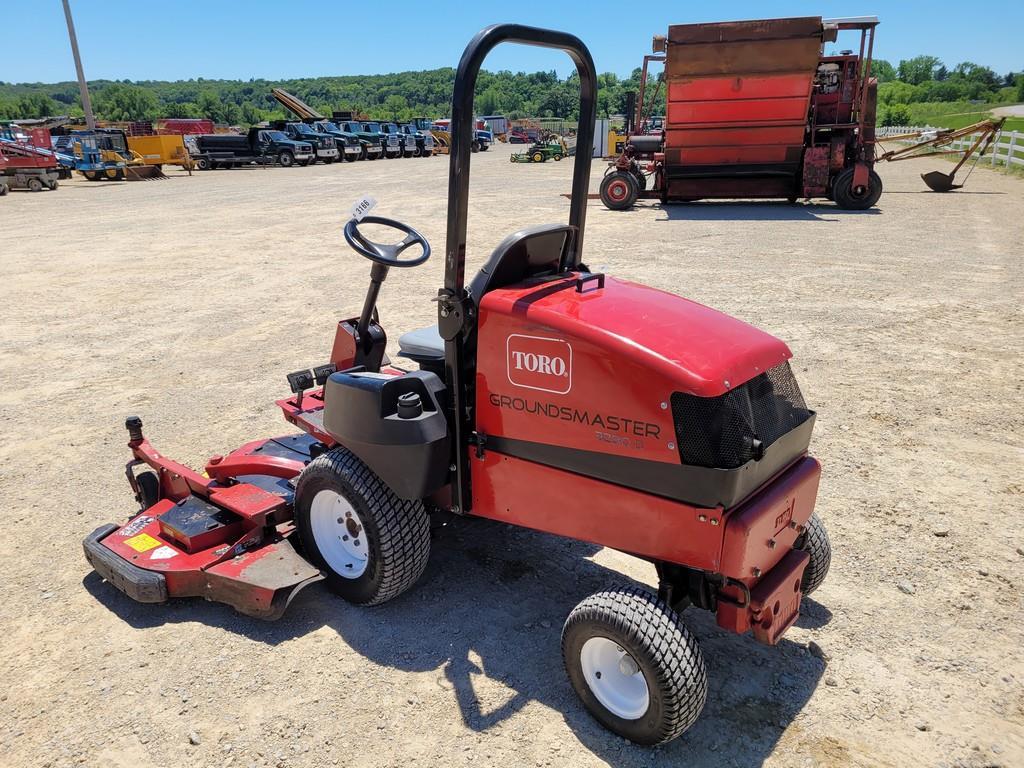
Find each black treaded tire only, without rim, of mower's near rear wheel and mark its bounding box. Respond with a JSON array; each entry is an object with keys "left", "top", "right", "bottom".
[{"left": 562, "top": 587, "right": 708, "bottom": 745}]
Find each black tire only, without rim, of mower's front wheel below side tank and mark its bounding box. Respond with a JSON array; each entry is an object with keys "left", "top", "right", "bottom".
[{"left": 295, "top": 446, "right": 430, "bottom": 605}]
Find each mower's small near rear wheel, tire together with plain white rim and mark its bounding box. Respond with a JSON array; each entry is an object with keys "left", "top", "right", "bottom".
[{"left": 562, "top": 588, "right": 708, "bottom": 745}]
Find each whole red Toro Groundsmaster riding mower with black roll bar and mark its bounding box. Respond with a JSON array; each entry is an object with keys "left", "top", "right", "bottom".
[{"left": 84, "top": 25, "right": 829, "bottom": 744}]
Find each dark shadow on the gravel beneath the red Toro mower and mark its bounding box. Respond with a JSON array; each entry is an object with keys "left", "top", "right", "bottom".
[{"left": 84, "top": 518, "right": 830, "bottom": 768}]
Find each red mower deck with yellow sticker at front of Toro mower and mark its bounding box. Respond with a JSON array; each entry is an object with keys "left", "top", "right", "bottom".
[{"left": 83, "top": 434, "right": 323, "bottom": 620}]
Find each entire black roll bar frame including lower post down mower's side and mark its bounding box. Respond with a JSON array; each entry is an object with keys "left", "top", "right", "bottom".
[{"left": 437, "top": 24, "right": 597, "bottom": 513}]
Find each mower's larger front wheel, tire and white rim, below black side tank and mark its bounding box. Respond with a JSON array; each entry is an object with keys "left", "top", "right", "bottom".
[{"left": 295, "top": 447, "right": 430, "bottom": 605}]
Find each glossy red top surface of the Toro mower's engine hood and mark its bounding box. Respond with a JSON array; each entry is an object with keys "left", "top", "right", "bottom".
[{"left": 481, "top": 276, "right": 793, "bottom": 397}]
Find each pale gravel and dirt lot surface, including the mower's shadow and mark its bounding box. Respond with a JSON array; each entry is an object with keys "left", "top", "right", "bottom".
[{"left": 0, "top": 146, "right": 1024, "bottom": 768}]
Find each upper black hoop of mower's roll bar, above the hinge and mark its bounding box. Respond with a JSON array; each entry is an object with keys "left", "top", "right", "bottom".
[{"left": 444, "top": 24, "right": 597, "bottom": 295}]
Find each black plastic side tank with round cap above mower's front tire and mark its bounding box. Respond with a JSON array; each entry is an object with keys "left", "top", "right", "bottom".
[{"left": 324, "top": 371, "right": 451, "bottom": 499}]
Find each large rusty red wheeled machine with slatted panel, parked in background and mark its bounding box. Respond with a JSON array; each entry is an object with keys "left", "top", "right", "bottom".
[{"left": 601, "top": 16, "right": 882, "bottom": 210}]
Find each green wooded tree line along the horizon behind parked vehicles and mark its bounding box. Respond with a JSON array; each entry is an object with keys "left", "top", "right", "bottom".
[{"left": 0, "top": 55, "right": 1024, "bottom": 125}]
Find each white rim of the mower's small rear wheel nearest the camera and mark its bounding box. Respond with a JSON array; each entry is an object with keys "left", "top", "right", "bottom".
[{"left": 580, "top": 637, "right": 650, "bottom": 720}]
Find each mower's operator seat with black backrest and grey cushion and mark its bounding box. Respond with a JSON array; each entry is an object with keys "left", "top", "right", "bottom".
[{"left": 398, "top": 224, "right": 575, "bottom": 370}]
